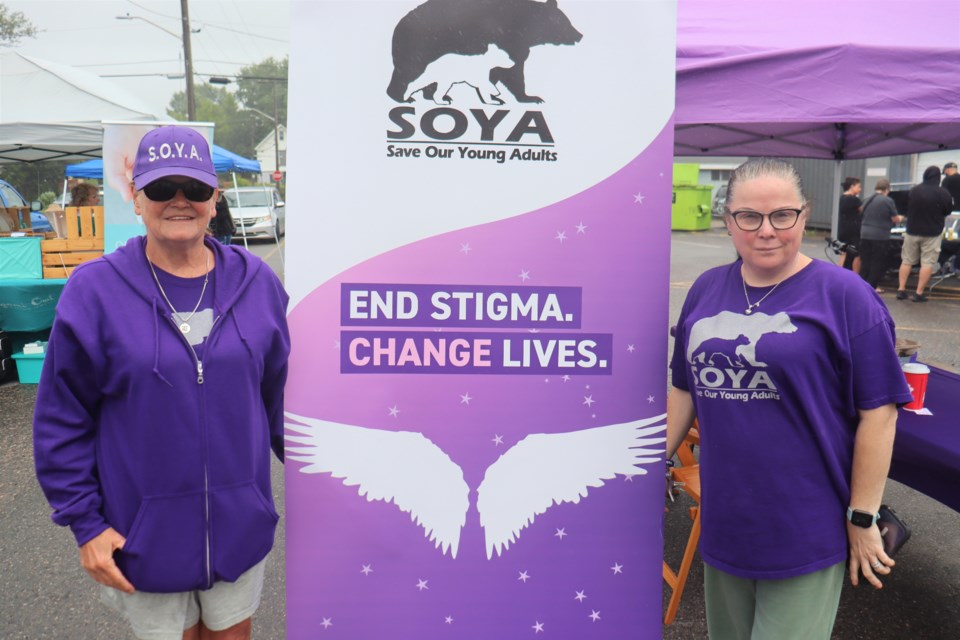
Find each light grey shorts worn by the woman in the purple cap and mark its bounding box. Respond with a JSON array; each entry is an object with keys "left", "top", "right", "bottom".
[{"left": 100, "top": 559, "right": 267, "bottom": 640}]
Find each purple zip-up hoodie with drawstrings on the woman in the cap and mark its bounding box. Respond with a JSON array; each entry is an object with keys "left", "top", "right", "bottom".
[{"left": 34, "top": 237, "right": 290, "bottom": 592}]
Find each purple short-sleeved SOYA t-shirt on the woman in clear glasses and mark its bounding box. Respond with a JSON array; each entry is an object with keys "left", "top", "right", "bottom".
[{"left": 671, "top": 260, "right": 911, "bottom": 579}]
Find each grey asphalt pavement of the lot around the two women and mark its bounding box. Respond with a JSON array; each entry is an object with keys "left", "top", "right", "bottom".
[{"left": 0, "top": 231, "right": 960, "bottom": 640}]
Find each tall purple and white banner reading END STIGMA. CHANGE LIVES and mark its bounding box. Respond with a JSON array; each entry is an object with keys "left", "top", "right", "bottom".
[{"left": 285, "top": 0, "right": 676, "bottom": 640}]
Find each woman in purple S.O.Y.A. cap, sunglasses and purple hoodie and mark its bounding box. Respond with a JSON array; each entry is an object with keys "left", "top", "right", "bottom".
[{"left": 34, "top": 126, "right": 289, "bottom": 638}]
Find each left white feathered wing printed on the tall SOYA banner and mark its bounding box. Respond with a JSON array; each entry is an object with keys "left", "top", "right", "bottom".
[{"left": 285, "top": 413, "right": 470, "bottom": 558}]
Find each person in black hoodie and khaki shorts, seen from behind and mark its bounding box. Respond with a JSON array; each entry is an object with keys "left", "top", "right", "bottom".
[{"left": 897, "top": 166, "right": 953, "bottom": 302}]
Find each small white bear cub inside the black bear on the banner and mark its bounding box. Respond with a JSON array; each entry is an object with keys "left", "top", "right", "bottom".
[{"left": 406, "top": 44, "right": 513, "bottom": 104}]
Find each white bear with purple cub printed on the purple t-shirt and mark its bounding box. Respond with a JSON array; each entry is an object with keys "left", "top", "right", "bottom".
[{"left": 687, "top": 311, "right": 797, "bottom": 367}]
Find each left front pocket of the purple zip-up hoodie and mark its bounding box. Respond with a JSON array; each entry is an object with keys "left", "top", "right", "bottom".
[{"left": 118, "top": 493, "right": 206, "bottom": 592}]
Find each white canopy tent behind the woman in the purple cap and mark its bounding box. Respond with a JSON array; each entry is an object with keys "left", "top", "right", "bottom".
[{"left": 0, "top": 51, "right": 160, "bottom": 162}]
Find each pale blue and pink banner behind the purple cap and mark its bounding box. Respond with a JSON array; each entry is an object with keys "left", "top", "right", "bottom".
[{"left": 103, "top": 121, "right": 213, "bottom": 253}]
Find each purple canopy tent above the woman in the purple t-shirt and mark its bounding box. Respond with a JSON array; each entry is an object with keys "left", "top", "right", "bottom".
[{"left": 674, "top": 0, "right": 960, "bottom": 229}]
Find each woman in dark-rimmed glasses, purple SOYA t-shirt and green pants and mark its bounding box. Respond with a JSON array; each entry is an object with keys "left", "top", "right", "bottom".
[{"left": 667, "top": 159, "right": 911, "bottom": 640}]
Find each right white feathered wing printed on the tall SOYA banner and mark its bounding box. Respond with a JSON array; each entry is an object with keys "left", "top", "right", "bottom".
[{"left": 477, "top": 414, "right": 666, "bottom": 559}]
